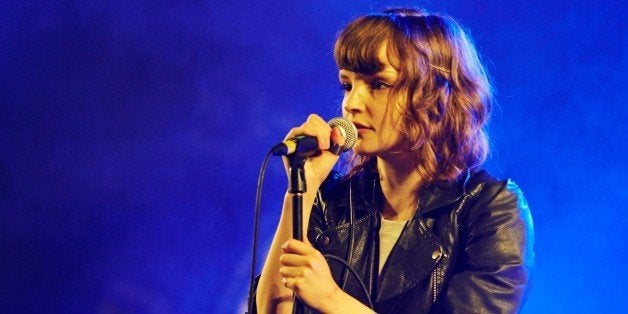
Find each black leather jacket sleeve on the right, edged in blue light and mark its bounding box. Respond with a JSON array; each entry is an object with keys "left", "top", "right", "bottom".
[{"left": 432, "top": 180, "right": 534, "bottom": 313}]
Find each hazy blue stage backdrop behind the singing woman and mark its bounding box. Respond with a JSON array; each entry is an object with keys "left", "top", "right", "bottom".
[{"left": 0, "top": 0, "right": 628, "bottom": 313}]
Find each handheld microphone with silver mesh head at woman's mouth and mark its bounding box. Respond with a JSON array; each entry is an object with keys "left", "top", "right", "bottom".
[{"left": 272, "top": 117, "right": 358, "bottom": 158}]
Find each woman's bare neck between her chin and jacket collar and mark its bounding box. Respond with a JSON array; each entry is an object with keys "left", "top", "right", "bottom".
[{"left": 377, "top": 158, "right": 421, "bottom": 220}]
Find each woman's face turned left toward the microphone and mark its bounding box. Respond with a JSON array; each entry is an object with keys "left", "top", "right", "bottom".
[{"left": 338, "top": 44, "right": 402, "bottom": 156}]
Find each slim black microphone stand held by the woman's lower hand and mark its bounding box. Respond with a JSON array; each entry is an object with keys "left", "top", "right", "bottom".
[{"left": 288, "top": 154, "right": 307, "bottom": 314}]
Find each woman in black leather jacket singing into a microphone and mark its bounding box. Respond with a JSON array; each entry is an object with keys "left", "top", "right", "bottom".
[{"left": 256, "top": 9, "right": 534, "bottom": 313}]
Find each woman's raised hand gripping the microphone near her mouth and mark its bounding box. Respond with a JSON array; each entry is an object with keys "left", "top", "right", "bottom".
[{"left": 284, "top": 114, "right": 344, "bottom": 192}]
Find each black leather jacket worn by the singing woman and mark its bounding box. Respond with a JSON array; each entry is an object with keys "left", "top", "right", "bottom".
[{"left": 308, "top": 171, "right": 534, "bottom": 313}]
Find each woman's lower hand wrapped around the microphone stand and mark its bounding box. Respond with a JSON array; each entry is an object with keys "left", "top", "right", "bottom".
[{"left": 279, "top": 239, "right": 342, "bottom": 312}]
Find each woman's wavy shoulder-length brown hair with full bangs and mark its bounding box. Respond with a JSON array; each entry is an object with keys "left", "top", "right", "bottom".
[{"left": 334, "top": 9, "right": 493, "bottom": 184}]
